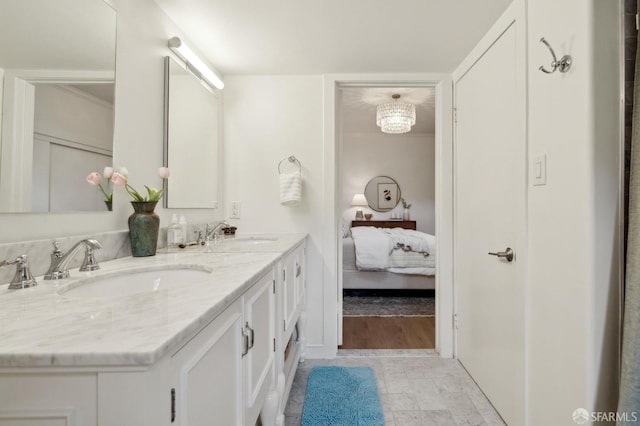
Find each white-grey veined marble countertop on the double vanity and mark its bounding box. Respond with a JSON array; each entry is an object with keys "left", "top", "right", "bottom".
[{"left": 0, "top": 234, "right": 306, "bottom": 368}]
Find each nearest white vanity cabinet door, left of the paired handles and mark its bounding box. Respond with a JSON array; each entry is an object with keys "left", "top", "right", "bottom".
[{"left": 172, "top": 300, "right": 243, "bottom": 426}]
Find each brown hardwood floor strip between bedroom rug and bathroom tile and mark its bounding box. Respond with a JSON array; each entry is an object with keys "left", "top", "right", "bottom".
[{"left": 340, "top": 317, "right": 436, "bottom": 349}]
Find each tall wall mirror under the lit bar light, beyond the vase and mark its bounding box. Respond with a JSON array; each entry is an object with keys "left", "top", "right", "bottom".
[{"left": 163, "top": 56, "right": 219, "bottom": 209}]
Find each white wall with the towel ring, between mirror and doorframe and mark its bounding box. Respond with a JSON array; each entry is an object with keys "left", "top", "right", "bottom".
[{"left": 224, "top": 75, "right": 324, "bottom": 350}]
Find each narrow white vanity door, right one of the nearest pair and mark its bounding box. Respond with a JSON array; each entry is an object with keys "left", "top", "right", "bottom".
[{"left": 244, "top": 272, "right": 275, "bottom": 426}]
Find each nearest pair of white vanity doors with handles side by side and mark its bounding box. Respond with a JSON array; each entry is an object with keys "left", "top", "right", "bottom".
[{"left": 171, "top": 272, "right": 275, "bottom": 426}]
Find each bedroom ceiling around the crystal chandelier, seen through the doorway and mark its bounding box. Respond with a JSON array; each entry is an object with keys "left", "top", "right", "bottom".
[{"left": 340, "top": 87, "right": 435, "bottom": 137}]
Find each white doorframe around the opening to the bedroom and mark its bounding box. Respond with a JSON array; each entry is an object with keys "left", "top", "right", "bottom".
[{"left": 320, "top": 73, "right": 454, "bottom": 358}]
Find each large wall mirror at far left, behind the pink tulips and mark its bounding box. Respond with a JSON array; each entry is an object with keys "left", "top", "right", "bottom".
[{"left": 0, "top": 0, "right": 116, "bottom": 212}]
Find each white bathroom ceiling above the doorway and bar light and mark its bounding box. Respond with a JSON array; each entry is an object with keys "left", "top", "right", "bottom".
[{"left": 155, "top": 0, "right": 511, "bottom": 74}]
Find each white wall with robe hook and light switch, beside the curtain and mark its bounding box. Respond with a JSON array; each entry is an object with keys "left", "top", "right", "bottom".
[{"left": 526, "top": 0, "right": 621, "bottom": 425}]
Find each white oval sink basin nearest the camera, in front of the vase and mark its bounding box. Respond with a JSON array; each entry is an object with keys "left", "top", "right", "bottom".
[{"left": 58, "top": 265, "right": 212, "bottom": 297}]
